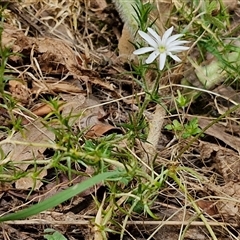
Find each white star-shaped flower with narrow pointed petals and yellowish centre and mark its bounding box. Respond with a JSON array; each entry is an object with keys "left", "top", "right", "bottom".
[{"left": 133, "top": 27, "right": 189, "bottom": 70}]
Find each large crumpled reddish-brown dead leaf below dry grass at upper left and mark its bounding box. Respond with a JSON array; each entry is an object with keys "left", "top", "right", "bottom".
[{"left": 2, "top": 24, "right": 79, "bottom": 77}]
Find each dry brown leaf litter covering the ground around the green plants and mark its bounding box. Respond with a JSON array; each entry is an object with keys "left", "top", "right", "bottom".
[{"left": 0, "top": 0, "right": 240, "bottom": 239}]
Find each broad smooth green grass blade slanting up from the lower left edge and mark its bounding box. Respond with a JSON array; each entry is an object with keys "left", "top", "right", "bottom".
[{"left": 0, "top": 171, "right": 120, "bottom": 222}]
